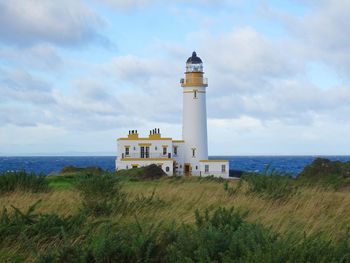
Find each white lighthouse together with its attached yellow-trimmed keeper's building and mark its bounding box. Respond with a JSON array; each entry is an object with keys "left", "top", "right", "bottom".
[{"left": 116, "top": 52, "right": 229, "bottom": 178}]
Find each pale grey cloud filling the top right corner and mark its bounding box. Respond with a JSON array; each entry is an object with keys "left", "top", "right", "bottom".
[{"left": 264, "top": 0, "right": 350, "bottom": 76}]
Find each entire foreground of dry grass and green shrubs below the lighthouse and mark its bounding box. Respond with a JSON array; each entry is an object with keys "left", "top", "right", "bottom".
[{"left": 0, "top": 167, "right": 350, "bottom": 262}]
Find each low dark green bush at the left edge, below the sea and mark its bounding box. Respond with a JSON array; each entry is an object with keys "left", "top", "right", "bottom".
[{"left": 0, "top": 171, "right": 50, "bottom": 194}]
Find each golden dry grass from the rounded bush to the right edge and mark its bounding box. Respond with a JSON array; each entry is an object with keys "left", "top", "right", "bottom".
[{"left": 119, "top": 178, "right": 350, "bottom": 240}]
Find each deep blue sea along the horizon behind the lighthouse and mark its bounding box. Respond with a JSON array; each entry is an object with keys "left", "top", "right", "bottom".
[{"left": 0, "top": 156, "right": 350, "bottom": 175}]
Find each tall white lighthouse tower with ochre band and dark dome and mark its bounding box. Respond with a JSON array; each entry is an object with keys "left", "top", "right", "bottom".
[{"left": 181, "top": 52, "right": 208, "bottom": 175}]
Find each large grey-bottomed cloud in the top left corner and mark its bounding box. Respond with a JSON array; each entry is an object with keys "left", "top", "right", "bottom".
[{"left": 0, "top": 0, "right": 103, "bottom": 46}]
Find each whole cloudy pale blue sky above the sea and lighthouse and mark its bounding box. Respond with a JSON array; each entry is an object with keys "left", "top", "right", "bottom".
[{"left": 0, "top": 0, "right": 350, "bottom": 156}]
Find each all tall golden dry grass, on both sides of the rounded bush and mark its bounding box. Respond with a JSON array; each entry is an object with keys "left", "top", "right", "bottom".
[{"left": 0, "top": 177, "right": 350, "bottom": 240}]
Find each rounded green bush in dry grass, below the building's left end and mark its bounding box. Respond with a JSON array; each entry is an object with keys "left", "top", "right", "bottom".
[{"left": 75, "top": 173, "right": 126, "bottom": 215}]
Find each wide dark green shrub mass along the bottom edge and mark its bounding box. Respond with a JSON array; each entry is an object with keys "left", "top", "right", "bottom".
[{"left": 37, "top": 208, "right": 350, "bottom": 262}]
